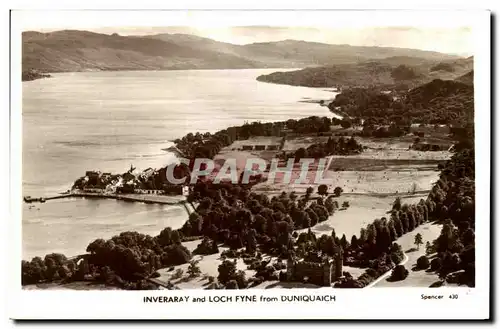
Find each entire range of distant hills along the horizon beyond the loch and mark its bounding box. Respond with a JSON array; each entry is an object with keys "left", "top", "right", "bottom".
[{"left": 22, "top": 30, "right": 457, "bottom": 72}]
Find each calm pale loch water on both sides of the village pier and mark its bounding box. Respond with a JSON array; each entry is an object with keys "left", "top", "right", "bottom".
[{"left": 23, "top": 69, "right": 335, "bottom": 259}]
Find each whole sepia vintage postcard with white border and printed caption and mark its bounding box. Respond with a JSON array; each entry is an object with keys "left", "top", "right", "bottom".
[{"left": 9, "top": 10, "right": 491, "bottom": 320}]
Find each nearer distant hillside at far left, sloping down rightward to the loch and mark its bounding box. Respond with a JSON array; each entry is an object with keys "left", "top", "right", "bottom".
[{"left": 23, "top": 31, "right": 258, "bottom": 72}]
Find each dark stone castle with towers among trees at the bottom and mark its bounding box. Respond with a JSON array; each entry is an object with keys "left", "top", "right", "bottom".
[{"left": 287, "top": 249, "right": 343, "bottom": 287}]
